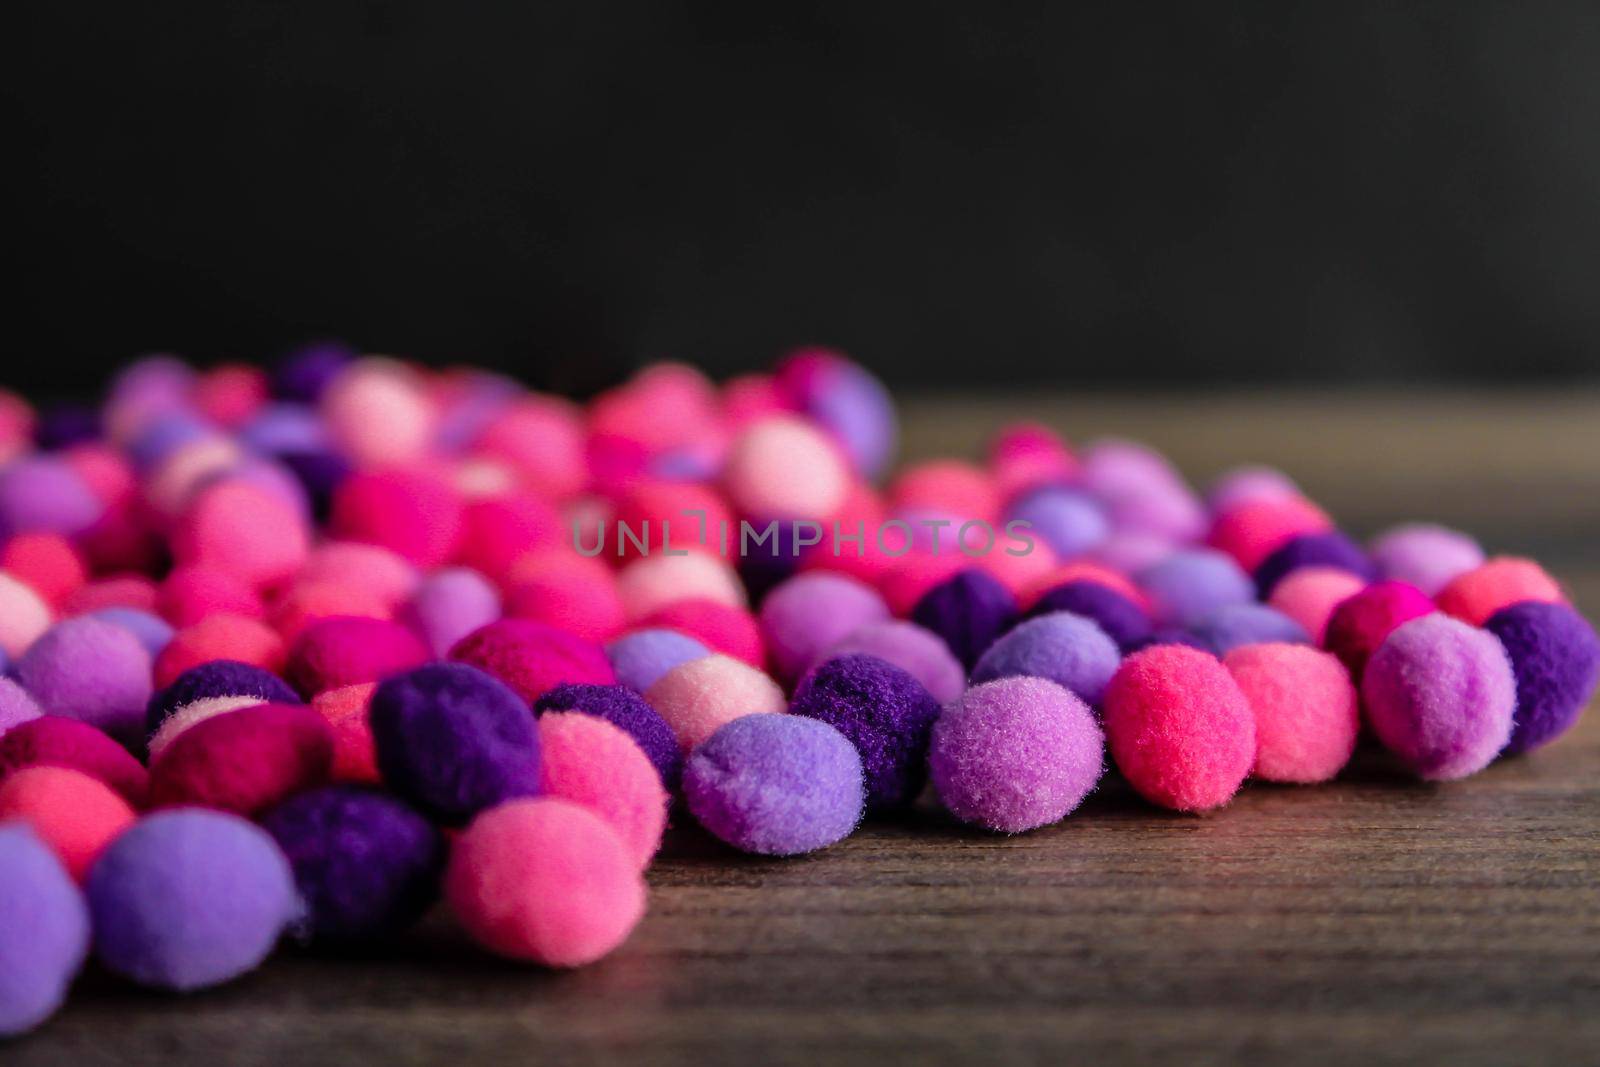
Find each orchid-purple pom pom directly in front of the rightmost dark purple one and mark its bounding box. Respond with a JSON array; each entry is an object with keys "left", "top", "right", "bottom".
[{"left": 1362, "top": 613, "right": 1517, "bottom": 781}]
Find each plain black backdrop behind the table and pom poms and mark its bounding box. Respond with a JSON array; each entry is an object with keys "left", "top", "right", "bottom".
[{"left": 12, "top": 0, "right": 1600, "bottom": 392}]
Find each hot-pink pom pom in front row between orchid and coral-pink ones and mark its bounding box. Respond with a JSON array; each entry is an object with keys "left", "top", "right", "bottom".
[{"left": 1106, "top": 645, "right": 1256, "bottom": 811}]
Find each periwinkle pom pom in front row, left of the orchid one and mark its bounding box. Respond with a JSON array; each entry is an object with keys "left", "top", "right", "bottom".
[{"left": 683, "top": 715, "right": 864, "bottom": 856}]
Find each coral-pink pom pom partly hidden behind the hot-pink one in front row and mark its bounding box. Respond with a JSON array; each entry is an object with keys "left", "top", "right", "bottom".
[{"left": 1222, "top": 645, "right": 1362, "bottom": 784}]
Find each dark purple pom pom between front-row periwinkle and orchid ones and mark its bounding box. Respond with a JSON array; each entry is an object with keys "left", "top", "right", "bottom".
[{"left": 789, "top": 656, "right": 939, "bottom": 809}]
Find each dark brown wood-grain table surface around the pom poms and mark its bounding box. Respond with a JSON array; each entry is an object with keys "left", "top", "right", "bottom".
[{"left": 0, "top": 392, "right": 1600, "bottom": 1067}]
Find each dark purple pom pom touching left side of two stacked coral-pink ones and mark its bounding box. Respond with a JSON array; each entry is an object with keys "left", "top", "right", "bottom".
[{"left": 370, "top": 664, "right": 539, "bottom": 825}]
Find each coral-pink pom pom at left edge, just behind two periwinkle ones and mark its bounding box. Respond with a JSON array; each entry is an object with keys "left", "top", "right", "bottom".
[{"left": 0, "top": 766, "right": 134, "bottom": 881}]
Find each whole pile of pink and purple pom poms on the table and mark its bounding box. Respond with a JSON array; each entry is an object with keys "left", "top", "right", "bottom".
[{"left": 0, "top": 344, "right": 1600, "bottom": 1035}]
